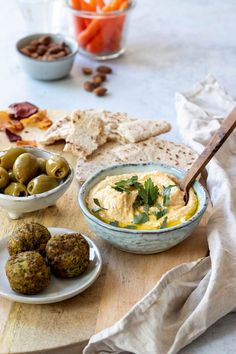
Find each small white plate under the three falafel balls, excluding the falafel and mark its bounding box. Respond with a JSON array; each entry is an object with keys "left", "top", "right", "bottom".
[{"left": 0, "top": 227, "right": 102, "bottom": 304}]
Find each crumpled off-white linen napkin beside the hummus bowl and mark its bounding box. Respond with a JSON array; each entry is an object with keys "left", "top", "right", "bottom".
[{"left": 83, "top": 76, "right": 236, "bottom": 354}]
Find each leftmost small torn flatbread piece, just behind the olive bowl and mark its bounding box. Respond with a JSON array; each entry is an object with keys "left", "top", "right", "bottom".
[{"left": 41, "top": 115, "right": 72, "bottom": 145}]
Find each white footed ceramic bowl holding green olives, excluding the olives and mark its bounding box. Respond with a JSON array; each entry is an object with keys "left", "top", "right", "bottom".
[{"left": 0, "top": 146, "right": 74, "bottom": 220}]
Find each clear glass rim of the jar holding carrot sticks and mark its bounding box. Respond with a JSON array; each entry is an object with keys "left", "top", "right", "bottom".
[{"left": 65, "top": 0, "right": 136, "bottom": 18}]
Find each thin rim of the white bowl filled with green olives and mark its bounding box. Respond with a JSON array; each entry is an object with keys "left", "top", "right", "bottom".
[{"left": 0, "top": 146, "right": 74, "bottom": 202}]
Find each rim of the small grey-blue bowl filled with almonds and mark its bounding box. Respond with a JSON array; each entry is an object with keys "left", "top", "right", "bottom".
[{"left": 15, "top": 32, "right": 79, "bottom": 65}]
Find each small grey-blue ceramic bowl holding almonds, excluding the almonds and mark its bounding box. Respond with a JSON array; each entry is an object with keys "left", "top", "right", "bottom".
[{"left": 16, "top": 33, "right": 78, "bottom": 81}]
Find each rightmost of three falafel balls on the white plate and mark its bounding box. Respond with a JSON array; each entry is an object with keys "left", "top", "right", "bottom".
[{"left": 46, "top": 233, "right": 89, "bottom": 278}]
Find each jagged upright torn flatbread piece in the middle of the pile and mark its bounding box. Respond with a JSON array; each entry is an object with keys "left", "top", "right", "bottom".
[{"left": 64, "top": 110, "right": 107, "bottom": 159}]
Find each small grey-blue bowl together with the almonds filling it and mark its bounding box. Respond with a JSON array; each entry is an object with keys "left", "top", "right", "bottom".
[{"left": 16, "top": 33, "right": 78, "bottom": 80}]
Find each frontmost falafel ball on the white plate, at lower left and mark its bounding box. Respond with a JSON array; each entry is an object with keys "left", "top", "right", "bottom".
[{"left": 5, "top": 251, "right": 50, "bottom": 295}]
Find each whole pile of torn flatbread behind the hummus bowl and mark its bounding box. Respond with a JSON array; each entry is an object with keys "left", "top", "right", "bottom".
[{"left": 41, "top": 109, "right": 197, "bottom": 183}]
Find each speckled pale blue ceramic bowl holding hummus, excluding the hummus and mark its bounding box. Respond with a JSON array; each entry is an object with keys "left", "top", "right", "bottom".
[{"left": 79, "top": 163, "right": 208, "bottom": 254}]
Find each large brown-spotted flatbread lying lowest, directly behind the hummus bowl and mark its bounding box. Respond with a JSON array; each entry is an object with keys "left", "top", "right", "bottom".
[{"left": 76, "top": 138, "right": 198, "bottom": 184}]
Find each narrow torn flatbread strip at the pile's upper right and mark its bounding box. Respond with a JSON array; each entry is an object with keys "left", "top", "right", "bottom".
[{"left": 117, "top": 120, "right": 171, "bottom": 143}]
